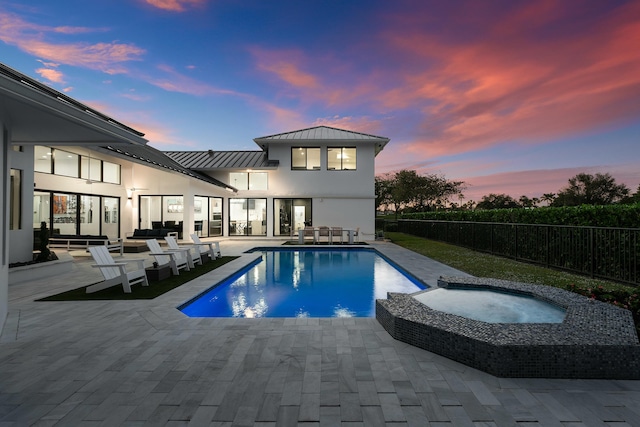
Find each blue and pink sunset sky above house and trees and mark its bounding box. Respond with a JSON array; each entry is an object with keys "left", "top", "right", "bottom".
[{"left": 0, "top": 0, "right": 640, "bottom": 200}]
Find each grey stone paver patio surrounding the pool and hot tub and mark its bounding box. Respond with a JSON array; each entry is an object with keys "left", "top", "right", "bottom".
[{"left": 0, "top": 240, "right": 640, "bottom": 427}]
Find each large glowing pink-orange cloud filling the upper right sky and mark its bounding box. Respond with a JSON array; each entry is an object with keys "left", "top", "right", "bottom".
[{"left": 378, "top": 1, "right": 640, "bottom": 154}]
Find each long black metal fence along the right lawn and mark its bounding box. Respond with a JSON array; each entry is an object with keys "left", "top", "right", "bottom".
[{"left": 396, "top": 220, "right": 640, "bottom": 286}]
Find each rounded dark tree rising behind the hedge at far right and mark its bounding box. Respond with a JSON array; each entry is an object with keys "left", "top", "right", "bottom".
[{"left": 552, "top": 173, "right": 630, "bottom": 206}]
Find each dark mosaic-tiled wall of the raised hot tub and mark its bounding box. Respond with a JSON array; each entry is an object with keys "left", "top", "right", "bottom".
[{"left": 376, "top": 277, "right": 640, "bottom": 379}]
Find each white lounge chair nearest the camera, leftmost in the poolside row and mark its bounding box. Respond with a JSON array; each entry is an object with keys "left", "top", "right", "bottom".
[{"left": 87, "top": 245, "right": 149, "bottom": 294}]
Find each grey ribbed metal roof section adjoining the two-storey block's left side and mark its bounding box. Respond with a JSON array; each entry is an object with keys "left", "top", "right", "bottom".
[{"left": 164, "top": 150, "right": 279, "bottom": 170}]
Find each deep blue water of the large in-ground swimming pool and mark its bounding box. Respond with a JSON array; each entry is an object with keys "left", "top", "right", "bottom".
[{"left": 180, "top": 249, "right": 425, "bottom": 317}]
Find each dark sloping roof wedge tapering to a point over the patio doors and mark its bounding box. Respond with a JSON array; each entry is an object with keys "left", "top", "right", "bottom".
[{"left": 102, "top": 145, "right": 238, "bottom": 191}]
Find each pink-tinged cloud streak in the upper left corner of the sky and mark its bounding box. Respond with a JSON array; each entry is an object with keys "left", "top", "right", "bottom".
[{"left": 0, "top": 13, "right": 145, "bottom": 74}]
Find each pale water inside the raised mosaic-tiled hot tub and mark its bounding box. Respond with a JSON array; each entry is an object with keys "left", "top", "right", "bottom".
[{"left": 413, "top": 288, "right": 566, "bottom": 323}]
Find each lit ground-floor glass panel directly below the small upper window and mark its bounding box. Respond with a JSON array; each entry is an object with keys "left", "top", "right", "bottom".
[{"left": 229, "top": 199, "right": 267, "bottom": 236}]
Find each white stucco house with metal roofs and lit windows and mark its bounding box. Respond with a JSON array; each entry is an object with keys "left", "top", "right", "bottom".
[{"left": 0, "top": 64, "right": 389, "bottom": 329}]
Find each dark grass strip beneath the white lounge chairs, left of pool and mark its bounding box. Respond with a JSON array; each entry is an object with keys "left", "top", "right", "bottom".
[{"left": 37, "top": 256, "right": 238, "bottom": 301}]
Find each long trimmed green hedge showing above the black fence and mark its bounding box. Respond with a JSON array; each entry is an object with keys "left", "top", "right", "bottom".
[{"left": 399, "top": 203, "right": 640, "bottom": 228}]
